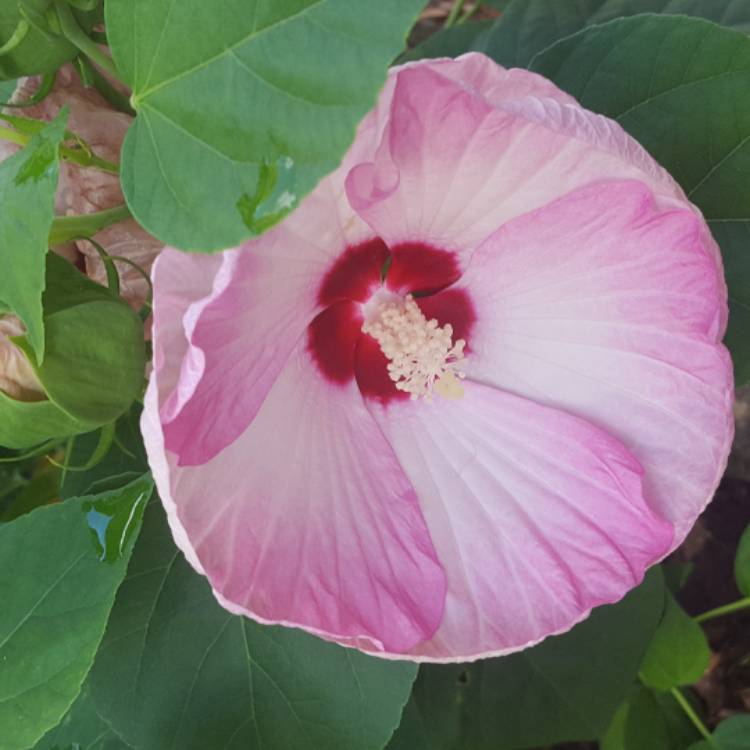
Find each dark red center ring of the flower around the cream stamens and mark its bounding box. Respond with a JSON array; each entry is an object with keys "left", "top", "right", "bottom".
[{"left": 308, "top": 238, "right": 475, "bottom": 403}]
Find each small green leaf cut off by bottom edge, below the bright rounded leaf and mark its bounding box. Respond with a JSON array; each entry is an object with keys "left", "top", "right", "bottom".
[{"left": 600, "top": 685, "right": 700, "bottom": 750}]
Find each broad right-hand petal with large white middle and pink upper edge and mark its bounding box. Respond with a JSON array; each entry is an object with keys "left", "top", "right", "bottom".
[{"left": 458, "top": 182, "right": 733, "bottom": 546}]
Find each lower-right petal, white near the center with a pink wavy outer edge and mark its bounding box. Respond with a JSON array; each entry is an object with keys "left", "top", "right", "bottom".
[{"left": 371, "top": 382, "right": 672, "bottom": 661}]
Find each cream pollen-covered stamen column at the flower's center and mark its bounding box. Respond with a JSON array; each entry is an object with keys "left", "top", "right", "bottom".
[{"left": 362, "top": 294, "right": 466, "bottom": 401}]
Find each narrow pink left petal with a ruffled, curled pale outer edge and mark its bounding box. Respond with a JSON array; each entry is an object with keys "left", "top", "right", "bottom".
[{"left": 155, "top": 174, "right": 372, "bottom": 466}]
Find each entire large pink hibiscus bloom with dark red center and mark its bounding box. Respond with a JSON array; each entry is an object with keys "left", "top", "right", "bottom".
[{"left": 143, "top": 54, "right": 733, "bottom": 661}]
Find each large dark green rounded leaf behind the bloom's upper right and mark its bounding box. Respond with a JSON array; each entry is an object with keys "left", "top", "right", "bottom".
[{"left": 532, "top": 16, "right": 750, "bottom": 384}]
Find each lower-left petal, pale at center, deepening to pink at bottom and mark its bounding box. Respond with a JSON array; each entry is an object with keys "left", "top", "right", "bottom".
[{"left": 143, "top": 344, "right": 445, "bottom": 653}]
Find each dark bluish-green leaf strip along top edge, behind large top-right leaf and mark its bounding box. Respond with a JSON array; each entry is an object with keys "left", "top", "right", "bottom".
[{"left": 482, "top": 0, "right": 750, "bottom": 68}]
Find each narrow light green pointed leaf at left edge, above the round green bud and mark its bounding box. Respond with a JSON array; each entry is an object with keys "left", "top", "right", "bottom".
[{"left": 0, "top": 108, "right": 67, "bottom": 362}]
